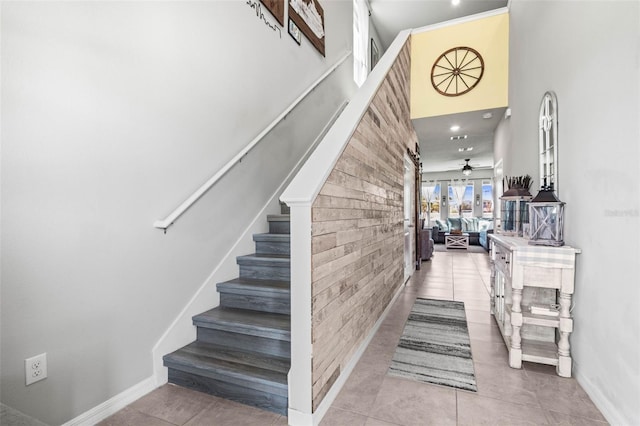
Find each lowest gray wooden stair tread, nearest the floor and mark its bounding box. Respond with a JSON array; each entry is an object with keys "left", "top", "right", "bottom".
[{"left": 164, "top": 342, "right": 289, "bottom": 389}]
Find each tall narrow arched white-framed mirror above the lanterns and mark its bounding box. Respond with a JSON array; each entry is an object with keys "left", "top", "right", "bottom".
[{"left": 538, "top": 92, "right": 559, "bottom": 195}]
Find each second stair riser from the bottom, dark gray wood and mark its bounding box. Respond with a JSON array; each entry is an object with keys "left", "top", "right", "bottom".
[{"left": 197, "top": 327, "right": 291, "bottom": 358}]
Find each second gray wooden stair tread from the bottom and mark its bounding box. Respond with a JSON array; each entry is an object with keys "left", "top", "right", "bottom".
[{"left": 193, "top": 307, "right": 291, "bottom": 341}]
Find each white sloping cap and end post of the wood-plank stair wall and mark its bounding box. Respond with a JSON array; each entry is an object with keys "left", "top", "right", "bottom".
[{"left": 280, "top": 30, "right": 411, "bottom": 425}]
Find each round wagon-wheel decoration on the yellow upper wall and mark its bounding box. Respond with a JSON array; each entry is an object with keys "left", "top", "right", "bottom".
[{"left": 431, "top": 47, "right": 484, "bottom": 96}]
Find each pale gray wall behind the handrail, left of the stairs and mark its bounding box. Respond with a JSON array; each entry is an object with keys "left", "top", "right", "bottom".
[{"left": 1, "top": 1, "right": 353, "bottom": 424}]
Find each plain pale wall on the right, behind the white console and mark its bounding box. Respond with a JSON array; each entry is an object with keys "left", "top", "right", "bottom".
[{"left": 504, "top": 0, "right": 640, "bottom": 425}]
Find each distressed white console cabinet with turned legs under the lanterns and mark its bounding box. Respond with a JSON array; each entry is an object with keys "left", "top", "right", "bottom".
[{"left": 489, "top": 234, "right": 580, "bottom": 377}]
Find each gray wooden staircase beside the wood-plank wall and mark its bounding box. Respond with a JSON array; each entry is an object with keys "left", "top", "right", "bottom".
[{"left": 163, "top": 210, "right": 291, "bottom": 416}]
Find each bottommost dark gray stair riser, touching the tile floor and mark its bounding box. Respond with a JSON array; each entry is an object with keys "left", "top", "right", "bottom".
[{"left": 169, "top": 368, "right": 288, "bottom": 416}]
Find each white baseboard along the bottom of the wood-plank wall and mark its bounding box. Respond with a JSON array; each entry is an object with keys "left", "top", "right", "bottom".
[{"left": 298, "top": 282, "right": 408, "bottom": 426}]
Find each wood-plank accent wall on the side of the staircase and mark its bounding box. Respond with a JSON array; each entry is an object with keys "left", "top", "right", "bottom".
[{"left": 311, "top": 41, "right": 417, "bottom": 411}]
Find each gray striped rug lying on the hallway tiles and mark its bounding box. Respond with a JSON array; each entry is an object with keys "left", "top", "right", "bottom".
[{"left": 389, "top": 298, "right": 478, "bottom": 392}]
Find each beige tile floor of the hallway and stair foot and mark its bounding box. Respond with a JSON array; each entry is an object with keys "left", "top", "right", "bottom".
[{"left": 100, "top": 251, "right": 607, "bottom": 426}]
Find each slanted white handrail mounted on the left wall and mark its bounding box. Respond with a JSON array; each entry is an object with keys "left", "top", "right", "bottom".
[{"left": 153, "top": 51, "right": 351, "bottom": 233}]
